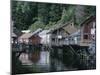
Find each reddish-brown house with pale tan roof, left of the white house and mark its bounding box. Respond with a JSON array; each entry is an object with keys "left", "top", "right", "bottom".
[{"left": 19, "top": 29, "right": 41, "bottom": 45}]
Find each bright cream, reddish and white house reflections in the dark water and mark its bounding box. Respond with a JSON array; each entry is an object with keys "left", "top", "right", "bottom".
[{"left": 19, "top": 47, "right": 50, "bottom": 72}]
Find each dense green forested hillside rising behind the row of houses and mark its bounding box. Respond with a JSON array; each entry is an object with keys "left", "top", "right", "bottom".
[{"left": 12, "top": 1, "right": 96, "bottom": 31}]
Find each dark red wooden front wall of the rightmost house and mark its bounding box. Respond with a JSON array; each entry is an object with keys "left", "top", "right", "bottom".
[{"left": 80, "top": 18, "right": 96, "bottom": 46}]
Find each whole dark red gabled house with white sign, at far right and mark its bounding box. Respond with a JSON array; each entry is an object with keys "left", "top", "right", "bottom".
[{"left": 80, "top": 16, "right": 96, "bottom": 46}]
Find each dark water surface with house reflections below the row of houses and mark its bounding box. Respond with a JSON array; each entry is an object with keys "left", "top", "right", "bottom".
[{"left": 13, "top": 46, "right": 95, "bottom": 74}]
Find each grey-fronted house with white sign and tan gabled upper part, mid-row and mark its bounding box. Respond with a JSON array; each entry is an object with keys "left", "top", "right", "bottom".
[{"left": 50, "top": 22, "right": 77, "bottom": 46}]
